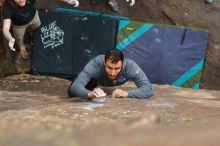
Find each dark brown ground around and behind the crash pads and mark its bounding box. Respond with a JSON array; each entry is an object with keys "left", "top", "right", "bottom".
[{"left": 0, "top": 0, "right": 220, "bottom": 89}]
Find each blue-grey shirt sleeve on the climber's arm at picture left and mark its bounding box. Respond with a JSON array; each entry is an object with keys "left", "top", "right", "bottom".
[{"left": 68, "top": 60, "right": 98, "bottom": 99}]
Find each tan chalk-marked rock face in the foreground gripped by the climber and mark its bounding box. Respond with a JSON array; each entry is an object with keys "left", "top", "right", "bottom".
[{"left": 0, "top": 75, "right": 220, "bottom": 146}]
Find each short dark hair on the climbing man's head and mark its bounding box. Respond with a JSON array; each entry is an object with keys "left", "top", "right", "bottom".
[{"left": 105, "top": 48, "right": 124, "bottom": 63}]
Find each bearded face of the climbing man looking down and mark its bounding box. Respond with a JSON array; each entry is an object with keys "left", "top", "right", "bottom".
[{"left": 104, "top": 59, "right": 122, "bottom": 80}]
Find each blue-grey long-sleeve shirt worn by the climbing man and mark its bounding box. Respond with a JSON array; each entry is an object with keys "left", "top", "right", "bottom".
[{"left": 68, "top": 55, "right": 153, "bottom": 99}]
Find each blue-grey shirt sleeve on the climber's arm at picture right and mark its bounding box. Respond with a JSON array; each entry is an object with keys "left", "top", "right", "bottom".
[{"left": 127, "top": 62, "right": 153, "bottom": 99}]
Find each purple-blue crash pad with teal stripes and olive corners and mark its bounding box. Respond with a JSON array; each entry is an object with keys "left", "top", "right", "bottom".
[{"left": 116, "top": 20, "right": 208, "bottom": 89}]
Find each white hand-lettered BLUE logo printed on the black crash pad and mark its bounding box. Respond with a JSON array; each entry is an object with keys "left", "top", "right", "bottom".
[{"left": 41, "top": 21, "right": 64, "bottom": 49}]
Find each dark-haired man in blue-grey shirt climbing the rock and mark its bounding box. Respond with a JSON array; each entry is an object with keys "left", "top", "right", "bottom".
[{"left": 68, "top": 48, "right": 153, "bottom": 100}]
